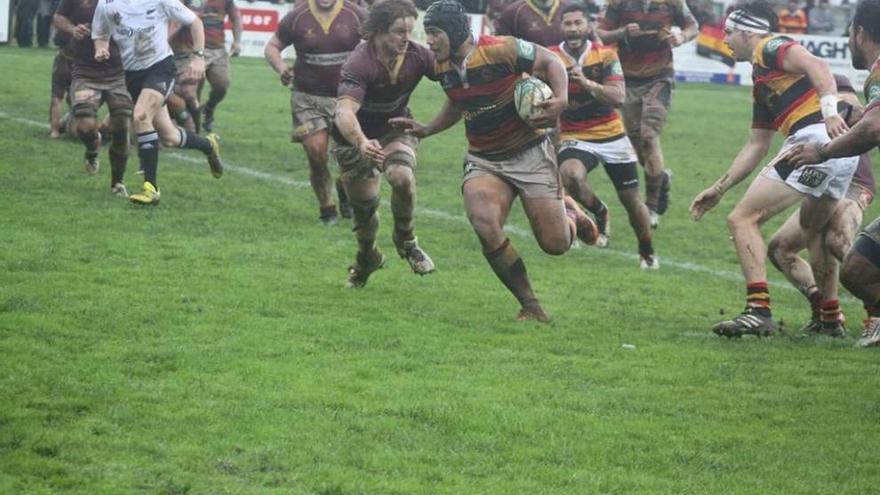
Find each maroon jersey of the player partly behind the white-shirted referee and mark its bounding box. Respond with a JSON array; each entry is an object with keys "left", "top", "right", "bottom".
[{"left": 56, "top": 0, "right": 124, "bottom": 80}]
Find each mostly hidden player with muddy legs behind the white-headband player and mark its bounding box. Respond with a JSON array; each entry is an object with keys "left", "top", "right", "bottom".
[{"left": 767, "top": 74, "right": 875, "bottom": 338}]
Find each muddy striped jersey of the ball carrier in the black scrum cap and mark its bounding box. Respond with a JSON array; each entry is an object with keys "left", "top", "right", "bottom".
[{"left": 435, "top": 35, "right": 545, "bottom": 160}]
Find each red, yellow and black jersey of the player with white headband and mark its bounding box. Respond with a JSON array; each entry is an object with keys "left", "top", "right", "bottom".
[{"left": 752, "top": 35, "right": 822, "bottom": 136}]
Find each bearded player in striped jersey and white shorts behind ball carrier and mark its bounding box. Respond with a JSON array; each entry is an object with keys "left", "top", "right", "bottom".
[{"left": 550, "top": 4, "right": 660, "bottom": 269}]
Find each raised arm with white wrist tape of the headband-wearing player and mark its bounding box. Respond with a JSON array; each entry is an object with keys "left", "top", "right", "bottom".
[{"left": 782, "top": 44, "right": 848, "bottom": 138}]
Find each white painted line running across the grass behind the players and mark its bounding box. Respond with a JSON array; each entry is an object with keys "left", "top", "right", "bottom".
[{"left": 0, "top": 111, "right": 812, "bottom": 294}]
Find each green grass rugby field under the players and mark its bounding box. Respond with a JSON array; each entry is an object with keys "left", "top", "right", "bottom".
[{"left": 0, "top": 44, "right": 880, "bottom": 495}]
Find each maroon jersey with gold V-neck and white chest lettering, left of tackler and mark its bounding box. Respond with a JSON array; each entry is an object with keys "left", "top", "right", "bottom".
[{"left": 275, "top": 0, "right": 367, "bottom": 96}]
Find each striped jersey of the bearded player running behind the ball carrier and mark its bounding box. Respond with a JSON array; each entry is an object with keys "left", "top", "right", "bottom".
[{"left": 550, "top": 41, "right": 626, "bottom": 142}]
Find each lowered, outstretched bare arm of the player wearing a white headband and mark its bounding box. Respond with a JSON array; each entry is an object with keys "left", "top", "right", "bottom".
[{"left": 690, "top": 128, "right": 776, "bottom": 220}]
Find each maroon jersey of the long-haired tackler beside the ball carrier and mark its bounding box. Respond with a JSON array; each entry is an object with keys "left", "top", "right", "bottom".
[{"left": 334, "top": 41, "right": 436, "bottom": 142}]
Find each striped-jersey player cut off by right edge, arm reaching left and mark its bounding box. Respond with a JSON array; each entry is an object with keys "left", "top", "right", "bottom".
[{"left": 786, "top": 0, "right": 880, "bottom": 347}]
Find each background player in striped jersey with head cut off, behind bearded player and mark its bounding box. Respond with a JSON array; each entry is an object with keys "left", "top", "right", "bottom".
[{"left": 596, "top": 0, "right": 699, "bottom": 227}]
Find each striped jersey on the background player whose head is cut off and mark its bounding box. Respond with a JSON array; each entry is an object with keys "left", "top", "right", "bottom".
[{"left": 599, "top": 0, "right": 697, "bottom": 83}]
